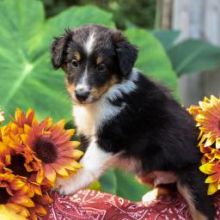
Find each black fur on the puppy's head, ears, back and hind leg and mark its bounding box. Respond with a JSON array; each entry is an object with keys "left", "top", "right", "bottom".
[{"left": 52, "top": 25, "right": 215, "bottom": 220}]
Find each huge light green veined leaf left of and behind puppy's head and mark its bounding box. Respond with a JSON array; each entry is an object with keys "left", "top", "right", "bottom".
[{"left": 0, "top": 0, "right": 114, "bottom": 119}]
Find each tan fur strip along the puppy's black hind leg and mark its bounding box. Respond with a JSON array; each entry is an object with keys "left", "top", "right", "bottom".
[{"left": 177, "top": 183, "right": 208, "bottom": 220}]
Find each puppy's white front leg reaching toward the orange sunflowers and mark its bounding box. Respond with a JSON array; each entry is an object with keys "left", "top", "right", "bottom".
[{"left": 56, "top": 141, "right": 118, "bottom": 195}]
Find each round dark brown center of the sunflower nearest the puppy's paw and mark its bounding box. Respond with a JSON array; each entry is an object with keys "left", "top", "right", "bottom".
[{"left": 35, "top": 138, "right": 57, "bottom": 163}]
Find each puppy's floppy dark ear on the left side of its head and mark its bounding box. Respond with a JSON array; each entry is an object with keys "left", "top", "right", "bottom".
[{"left": 51, "top": 31, "right": 71, "bottom": 69}]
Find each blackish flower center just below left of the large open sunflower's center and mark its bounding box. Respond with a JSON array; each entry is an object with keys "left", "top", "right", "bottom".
[{"left": 8, "top": 154, "right": 31, "bottom": 177}]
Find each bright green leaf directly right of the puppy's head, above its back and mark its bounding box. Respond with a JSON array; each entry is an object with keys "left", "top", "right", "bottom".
[{"left": 125, "top": 28, "right": 177, "bottom": 91}]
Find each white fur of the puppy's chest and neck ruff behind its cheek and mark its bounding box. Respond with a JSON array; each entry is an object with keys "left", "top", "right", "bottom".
[{"left": 73, "top": 69, "right": 138, "bottom": 137}]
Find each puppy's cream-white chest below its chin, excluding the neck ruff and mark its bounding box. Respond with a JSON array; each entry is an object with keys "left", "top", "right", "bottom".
[{"left": 73, "top": 102, "right": 121, "bottom": 137}]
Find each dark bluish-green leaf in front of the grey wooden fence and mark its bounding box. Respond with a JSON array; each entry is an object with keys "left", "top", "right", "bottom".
[{"left": 168, "top": 40, "right": 220, "bottom": 76}]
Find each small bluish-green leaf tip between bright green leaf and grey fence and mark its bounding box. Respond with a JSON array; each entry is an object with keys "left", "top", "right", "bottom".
[{"left": 152, "top": 30, "right": 180, "bottom": 50}]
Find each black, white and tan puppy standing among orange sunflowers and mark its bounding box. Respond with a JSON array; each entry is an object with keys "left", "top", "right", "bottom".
[{"left": 52, "top": 25, "right": 215, "bottom": 220}]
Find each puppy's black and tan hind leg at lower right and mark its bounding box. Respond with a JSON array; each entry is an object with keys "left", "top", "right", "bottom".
[{"left": 177, "top": 168, "right": 215, "bottom": 220}]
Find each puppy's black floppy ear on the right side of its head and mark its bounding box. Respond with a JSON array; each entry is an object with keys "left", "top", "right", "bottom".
[{"left": 113, "top": 31, "right": 138, "bottom": 76}]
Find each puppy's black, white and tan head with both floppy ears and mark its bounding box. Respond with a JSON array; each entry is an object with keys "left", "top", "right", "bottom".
[{"left": 52, "top": 25, "right": 137, "bottom": 104}]
